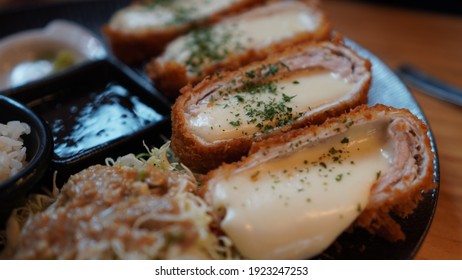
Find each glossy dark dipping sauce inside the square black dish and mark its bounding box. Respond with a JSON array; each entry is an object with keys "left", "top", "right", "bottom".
[{"left": 34, "top": 83, "right": 164, "bottom": 159}]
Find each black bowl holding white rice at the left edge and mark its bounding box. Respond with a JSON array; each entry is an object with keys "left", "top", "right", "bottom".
[{"left": 0, "top": 95, "right": 53, "bottom": 225}]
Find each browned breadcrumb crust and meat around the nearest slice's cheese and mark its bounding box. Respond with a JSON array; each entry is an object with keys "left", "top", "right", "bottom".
[{"left": 201, "top": 104, "right": 435, "bottom": 242}]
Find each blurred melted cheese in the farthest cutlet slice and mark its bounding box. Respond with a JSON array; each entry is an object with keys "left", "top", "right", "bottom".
[{"left": 110, "top": 0, "right": 239, "bottom": 32}]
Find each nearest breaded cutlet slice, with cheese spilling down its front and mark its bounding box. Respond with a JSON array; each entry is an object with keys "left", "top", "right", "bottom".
[{"left": 202, "top": 105, "right": 434, "bottom": 259}]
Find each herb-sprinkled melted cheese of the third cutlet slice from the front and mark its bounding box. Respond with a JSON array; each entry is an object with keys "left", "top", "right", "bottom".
[{"left": 158, "top": 1, "right": 321, "bottom": 76}]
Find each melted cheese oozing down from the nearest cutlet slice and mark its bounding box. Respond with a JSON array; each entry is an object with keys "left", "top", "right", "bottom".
[{"left": 208, "top": 121, "right": 393, "bottom": 259}]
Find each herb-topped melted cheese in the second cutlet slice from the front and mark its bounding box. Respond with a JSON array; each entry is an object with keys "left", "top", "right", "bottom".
[{"left": 187, "top": 71, "right": 354, "bottom": 142}]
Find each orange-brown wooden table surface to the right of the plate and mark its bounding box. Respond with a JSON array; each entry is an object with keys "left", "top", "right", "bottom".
[{"left": 323, "top": 0, "right": 462, "bottom": 259}]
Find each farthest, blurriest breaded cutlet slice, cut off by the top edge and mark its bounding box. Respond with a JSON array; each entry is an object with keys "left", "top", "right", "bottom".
[{"left": 103, "top": 0, "right": 266, "bottom": 64}]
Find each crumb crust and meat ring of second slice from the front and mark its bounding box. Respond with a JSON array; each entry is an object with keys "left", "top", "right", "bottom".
[{"left": 172, "top": 42, "right": 371, "bottom": 172}]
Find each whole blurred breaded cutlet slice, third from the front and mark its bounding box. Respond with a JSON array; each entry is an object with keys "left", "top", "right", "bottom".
[{"left": 146, "top": 0, "right": 331, "bottom": 98}]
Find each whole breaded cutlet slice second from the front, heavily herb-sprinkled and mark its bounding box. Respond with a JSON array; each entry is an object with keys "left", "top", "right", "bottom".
[{"left": 172, "top": 42, "right": 371, "bottom": 172}]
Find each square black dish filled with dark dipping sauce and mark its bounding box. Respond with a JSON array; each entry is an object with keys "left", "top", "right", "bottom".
[{"left": 5, "top": 59, "right": 171, "bottom": 186}]
